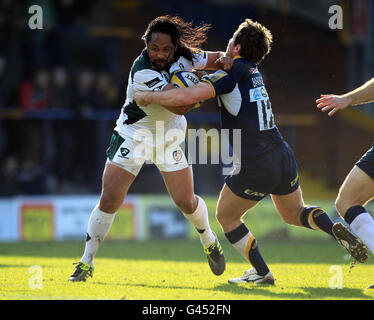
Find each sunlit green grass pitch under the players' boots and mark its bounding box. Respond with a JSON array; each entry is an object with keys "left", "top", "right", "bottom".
[{"left": 0, "top": 238, "right": 374, "bottom": 300}]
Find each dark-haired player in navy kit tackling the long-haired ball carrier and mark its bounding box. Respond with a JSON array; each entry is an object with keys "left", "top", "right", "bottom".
[{"left": 134, "top": 19, "right": 367, "bottom": 284}]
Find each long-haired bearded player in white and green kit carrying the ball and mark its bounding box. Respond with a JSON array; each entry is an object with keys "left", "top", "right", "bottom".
[{"left": 69, "top": 16, "right": 232, "bottom": 281}]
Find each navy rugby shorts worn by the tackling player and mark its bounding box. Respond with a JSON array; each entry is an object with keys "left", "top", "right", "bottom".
[{"left": 225, "top": 141, "right": 299, "bottom": 201}]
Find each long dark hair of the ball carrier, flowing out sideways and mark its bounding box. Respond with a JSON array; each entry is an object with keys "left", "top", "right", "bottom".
[{"left": 142, "top": 15, "right": 211, "bottom": 61}]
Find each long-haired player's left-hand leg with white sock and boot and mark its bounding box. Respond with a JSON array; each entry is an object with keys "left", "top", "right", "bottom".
[{"left": 69, "top": 164, "right": 135, "bottom": 281}]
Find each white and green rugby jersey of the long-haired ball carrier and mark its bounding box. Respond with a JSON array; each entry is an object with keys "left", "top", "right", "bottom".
[{"left": 116, "top": 49, "right": 208, "bottom": 134}]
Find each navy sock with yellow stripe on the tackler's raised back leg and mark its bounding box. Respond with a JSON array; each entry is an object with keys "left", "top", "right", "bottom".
[{"left": 300, "top": 206, "right": 335, "bottom": 238}]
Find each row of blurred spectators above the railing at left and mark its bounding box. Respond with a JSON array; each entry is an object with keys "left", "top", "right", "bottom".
[{"left": 17, "top": 66, "right": 119, "bottom": 115}]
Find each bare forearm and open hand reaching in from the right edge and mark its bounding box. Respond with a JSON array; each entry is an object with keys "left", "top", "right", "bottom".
[{"left": 316, "top": 78, "right": 374, "bottom": 116}]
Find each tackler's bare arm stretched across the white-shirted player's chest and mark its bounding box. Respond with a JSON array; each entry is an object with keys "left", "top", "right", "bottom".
[{"left": 134, "top": 82, "right": 215, "bottom": 107}]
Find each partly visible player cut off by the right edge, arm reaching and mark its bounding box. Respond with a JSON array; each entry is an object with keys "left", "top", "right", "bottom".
[{"left": 316, "top": 78, "right": 374, "bottom": 289}]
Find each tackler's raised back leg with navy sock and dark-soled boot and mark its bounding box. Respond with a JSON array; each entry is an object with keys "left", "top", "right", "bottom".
[{"left": 271, "top": 187, "right": 368, "bottom": 262}]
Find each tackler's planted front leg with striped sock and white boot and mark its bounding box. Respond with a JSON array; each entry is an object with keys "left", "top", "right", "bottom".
[{"left": 216, "top": 184, "right": 274, "bottom": 284}]
